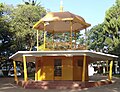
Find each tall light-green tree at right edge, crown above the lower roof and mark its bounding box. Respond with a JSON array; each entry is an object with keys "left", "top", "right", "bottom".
[{"left": 104, "top": 0, "right": 120, "bottom": 52}]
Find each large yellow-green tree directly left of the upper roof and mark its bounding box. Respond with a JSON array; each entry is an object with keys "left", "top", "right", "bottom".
[{"left": 10, "top": 4, "right": 46, "bottom": 51}]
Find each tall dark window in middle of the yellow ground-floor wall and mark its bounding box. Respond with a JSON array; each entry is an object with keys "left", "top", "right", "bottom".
[{"left": 54, "top": 59, "right": 62, "bottom": 76}]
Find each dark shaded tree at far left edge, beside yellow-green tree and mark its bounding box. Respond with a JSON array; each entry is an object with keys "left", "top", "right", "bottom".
[{"left": 0, "top": 4, "right": 13, "bottom": 76}]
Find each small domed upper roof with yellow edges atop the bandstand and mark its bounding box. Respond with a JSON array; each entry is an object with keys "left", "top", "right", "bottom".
[{"left": 33, "top": 12, "right": 90, "bottom": 33}]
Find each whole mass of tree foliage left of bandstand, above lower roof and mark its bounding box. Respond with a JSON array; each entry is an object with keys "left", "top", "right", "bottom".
[{"left": 0, "top": 0, "right": 46, "bottom": 56}]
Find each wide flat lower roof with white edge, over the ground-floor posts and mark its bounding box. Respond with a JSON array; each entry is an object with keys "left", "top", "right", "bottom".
[{"left": 9, "top": 50, "right": 118, "bottom": 62}]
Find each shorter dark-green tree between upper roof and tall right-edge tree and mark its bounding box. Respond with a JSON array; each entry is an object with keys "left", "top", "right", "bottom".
[{"left": 88, "top": 24, "right": 106, "bottom": 52}]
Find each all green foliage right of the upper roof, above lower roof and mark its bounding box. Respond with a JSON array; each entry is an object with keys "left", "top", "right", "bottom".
[{"left": 88, "top": 0, "right": 120, "bottom": 54}]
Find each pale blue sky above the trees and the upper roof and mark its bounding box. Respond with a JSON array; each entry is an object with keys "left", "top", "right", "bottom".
[{"left": 0, "top": 0, "right": 115, "bottom": 27}]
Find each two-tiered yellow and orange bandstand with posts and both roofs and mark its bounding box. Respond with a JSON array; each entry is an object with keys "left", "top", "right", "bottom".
[{"left": 10, "top": 3, "right": 117, "bottom": 88}]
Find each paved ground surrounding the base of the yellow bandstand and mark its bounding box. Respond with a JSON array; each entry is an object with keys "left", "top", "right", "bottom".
[{"left": 0, "top": 75, "right": 120, "bottom": 92}]
